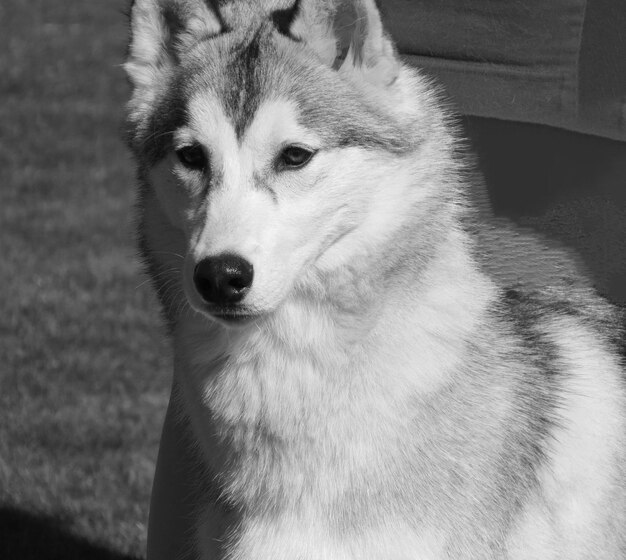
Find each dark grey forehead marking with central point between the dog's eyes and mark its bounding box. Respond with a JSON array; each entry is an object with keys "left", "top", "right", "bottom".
[{"left": 182, "top": 26, "right": 390, "bottom": 150}]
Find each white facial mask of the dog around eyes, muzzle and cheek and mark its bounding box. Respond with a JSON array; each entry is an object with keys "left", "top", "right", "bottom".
[{"left": 167, "top": 95, "right": 448, "bottom": 320}]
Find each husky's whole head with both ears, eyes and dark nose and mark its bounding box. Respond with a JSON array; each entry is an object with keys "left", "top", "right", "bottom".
[{"left": 126, "top": 0, "right": 422, "bottom": 322}]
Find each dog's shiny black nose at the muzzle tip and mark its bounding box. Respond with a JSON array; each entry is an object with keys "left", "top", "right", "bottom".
[{"left": 193, "top": 253, "right": 254, "bottom": 305}]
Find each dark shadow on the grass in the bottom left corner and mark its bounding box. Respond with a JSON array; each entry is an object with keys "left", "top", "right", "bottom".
[{"left": 0, "top": 508, "right": 139, "bottom": 560}]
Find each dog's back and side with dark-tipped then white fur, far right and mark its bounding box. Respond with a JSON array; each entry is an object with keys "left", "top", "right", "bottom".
[{"left": 473, "top": 220, "right": 626, "bottom": 558}]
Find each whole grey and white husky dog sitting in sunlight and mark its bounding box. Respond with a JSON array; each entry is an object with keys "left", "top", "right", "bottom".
[{"left": 125, "top": 0, "right": 626, "bottom": 560}]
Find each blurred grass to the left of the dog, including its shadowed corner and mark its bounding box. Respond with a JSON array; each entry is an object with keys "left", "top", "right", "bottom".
[{"left": 0, "top": 0, "right": 170, "bottom": 560}]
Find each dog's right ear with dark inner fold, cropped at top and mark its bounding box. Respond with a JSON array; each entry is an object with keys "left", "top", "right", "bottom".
[{"left": 279, "top": 0, "right": 400, "bottom": 86}]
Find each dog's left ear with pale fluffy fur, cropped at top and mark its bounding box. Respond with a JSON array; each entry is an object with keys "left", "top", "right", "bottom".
[{"left": 124, "top": 0, "right": 222, "bottom": 90}]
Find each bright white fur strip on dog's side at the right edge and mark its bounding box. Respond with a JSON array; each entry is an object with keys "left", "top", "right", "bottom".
[{"left": 510, "top": 318, "right": 626, "bottom": 560}]
